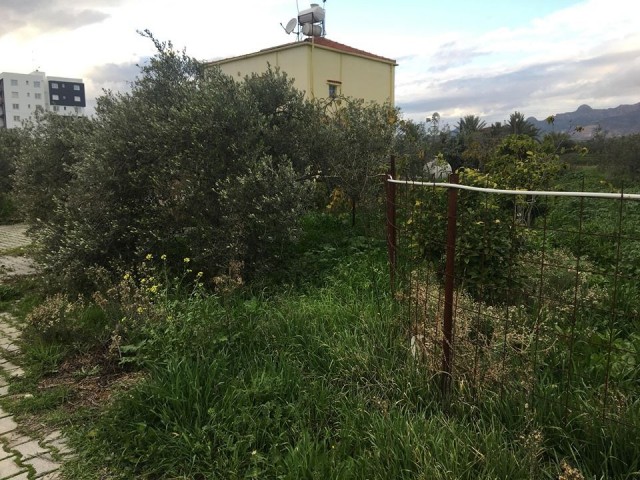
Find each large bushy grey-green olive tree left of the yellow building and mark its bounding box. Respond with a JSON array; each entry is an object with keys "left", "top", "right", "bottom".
[{"left": 24, "top": 32, "right": 314, "bottom": 288}]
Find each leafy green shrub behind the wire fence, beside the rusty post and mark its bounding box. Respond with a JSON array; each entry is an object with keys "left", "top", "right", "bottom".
[{"left": 403, "top": 170, "right": 525, "bottom": 303}]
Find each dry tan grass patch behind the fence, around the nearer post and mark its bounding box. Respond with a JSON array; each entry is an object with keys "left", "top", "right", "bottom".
[{"left": 405, "top": 270, "right": 554, "bottom": 390}]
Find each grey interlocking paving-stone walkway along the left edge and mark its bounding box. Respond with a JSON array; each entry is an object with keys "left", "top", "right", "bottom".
[{"left": 0, "top": 225, "right": 71, "bottom": 480}]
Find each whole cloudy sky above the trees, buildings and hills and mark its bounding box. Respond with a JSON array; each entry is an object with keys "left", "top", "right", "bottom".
[{"left": 0, "top": 0, "right": 640, "bottom": 124}]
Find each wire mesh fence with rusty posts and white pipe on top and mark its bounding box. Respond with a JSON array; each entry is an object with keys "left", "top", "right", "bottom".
[{"left": 386, "top": 173, "right": 640, "bottom": 446}]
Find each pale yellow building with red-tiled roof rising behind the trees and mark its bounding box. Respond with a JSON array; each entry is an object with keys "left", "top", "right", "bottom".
[{"left": 207, "top": 37, "right": 397, "bottom": 105}]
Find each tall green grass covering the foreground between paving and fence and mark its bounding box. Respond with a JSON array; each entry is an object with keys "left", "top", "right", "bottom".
[{"left": 6, "top": 216, "right": 640, "bottom": 479}]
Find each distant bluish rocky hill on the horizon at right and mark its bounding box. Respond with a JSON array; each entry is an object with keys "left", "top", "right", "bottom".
[{"left": 528, "top": 103, "right": 640, "bottom": 139}]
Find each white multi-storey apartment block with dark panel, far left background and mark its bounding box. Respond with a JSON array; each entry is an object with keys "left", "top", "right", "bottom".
[{"left": 0, "top": 71, "right": 87, "bottom": 128}]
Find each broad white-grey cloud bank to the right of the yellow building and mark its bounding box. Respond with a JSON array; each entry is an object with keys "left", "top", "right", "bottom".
[{"left": 396, "top": 0, "right": 640, "bottom": 121}]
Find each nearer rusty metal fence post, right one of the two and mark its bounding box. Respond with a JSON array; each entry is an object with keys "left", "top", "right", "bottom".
[{"left": 441, "top": 173, "right": 458, "bottom": 397}]
